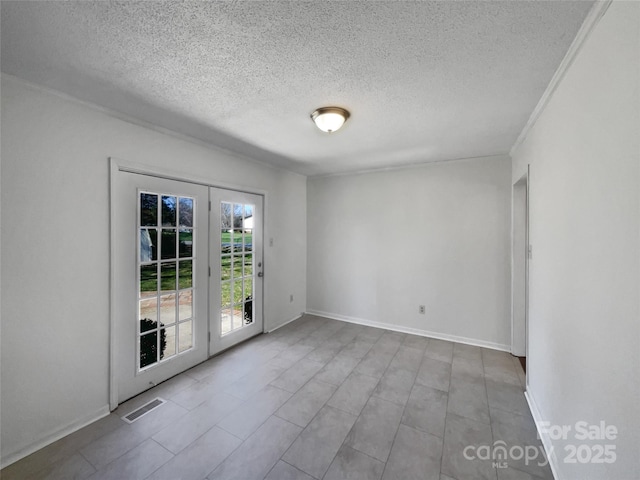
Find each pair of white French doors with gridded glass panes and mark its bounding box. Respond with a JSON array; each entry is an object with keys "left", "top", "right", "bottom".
[{"left": 112, "top": 167, "right": 263, "bottom": 407}]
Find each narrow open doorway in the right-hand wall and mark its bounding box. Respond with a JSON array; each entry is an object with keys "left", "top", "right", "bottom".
[{"left": 511, "top": 172, "right": 531, "bottom": 373}]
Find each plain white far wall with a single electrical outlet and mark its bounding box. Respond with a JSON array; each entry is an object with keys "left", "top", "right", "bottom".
[{"left": 307, "top": 157, "right": 511, "bottom": 349}]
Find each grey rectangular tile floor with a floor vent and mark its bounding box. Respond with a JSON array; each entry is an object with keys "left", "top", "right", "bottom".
[{"left": 1, "top": 315, "right": 553, "bottom": 480}]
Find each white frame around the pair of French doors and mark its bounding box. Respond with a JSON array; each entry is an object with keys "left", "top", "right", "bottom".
[{"left": 108, "top": 157, "right": 268, "bottom": 411}]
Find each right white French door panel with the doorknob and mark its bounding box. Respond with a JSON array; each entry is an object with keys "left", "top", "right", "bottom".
[{"left": 209, "top": 187, "right": 263, "bottom": 355}]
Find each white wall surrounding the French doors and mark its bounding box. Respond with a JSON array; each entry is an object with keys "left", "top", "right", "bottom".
[{"left": 1, "top": 76, "right": 306, "bottom": 464}]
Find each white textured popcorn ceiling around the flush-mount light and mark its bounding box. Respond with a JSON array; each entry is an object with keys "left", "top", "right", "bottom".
[{"left": 1, "top": 1, "right": 592, "bottom": 174}]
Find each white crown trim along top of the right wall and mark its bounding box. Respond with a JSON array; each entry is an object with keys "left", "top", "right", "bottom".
[{"left": 509, "top": 0, "right": 613, "bottom": 158}]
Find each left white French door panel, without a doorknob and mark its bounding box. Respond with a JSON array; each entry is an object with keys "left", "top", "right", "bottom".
[{"left": 114, "top": 172, "right": 209, "bottom": 403}]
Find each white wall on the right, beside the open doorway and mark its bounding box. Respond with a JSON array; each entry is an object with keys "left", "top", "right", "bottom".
[{"left": 513, "top": 2, "right": 640, "bottom": 480}]
